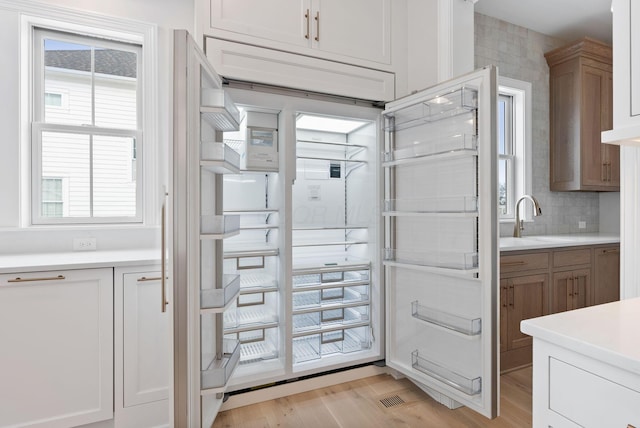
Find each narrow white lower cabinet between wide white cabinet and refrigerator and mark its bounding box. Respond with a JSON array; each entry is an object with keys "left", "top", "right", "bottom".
[{"left": 114, "top": 266, "right": 172, "bottom": 428}]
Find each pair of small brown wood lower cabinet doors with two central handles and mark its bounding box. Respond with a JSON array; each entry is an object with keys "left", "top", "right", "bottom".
[{"left": 551, "top": 267, "right": 591, "bottom": 313}]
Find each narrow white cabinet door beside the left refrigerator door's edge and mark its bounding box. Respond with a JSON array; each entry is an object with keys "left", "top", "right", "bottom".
[{"left": 123, "top": 272, "right": 171, "bottom": 407}]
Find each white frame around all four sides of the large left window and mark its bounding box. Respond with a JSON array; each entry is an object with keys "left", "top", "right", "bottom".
[{"left": 19, "top": 4, "right": 158, "bottom": 229}]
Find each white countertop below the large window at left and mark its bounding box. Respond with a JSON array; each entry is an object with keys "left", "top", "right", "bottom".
[{"left": 0, "top": 248, "right": 160, "bottom": 273}]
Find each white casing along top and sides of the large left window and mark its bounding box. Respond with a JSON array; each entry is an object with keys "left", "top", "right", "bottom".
[{"left": 14, "top": 0, "right": 162, "bottom": 227}]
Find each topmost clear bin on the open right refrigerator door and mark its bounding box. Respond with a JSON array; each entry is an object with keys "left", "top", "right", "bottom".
[{"left": 384, "top": 86, "right": 478, "bottom": 131}]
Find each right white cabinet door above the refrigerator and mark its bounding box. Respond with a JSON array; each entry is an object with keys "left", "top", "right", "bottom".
[{"left": 311, "top": 0, "right": 391, "bottom": 64}]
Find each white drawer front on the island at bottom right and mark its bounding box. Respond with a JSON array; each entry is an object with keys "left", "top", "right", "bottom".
[{"left": 549, "top": 358, "right": 640, "bottom": 427}]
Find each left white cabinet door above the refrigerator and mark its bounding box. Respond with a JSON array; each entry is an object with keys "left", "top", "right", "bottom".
[{"left": 210, "top": 0, "right": 313, "bottom": 47}]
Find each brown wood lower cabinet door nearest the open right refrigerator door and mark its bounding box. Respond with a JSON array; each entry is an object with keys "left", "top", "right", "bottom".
[{"left": 507, "top": 274, "right": 548, "bottom": 349}]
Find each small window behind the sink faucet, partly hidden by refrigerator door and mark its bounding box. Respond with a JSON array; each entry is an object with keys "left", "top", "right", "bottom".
[{"left": 498, "top": 77, "right": 532, "bottom": 222}]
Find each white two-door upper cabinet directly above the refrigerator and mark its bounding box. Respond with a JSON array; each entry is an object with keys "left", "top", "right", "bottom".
[{"left": 203, "top": 0, "right": 391, "bottom": 71}]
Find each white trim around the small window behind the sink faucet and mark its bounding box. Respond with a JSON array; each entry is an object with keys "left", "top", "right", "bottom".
[{"left": 496, "top": 76, "right": 533, "bottom": 223}]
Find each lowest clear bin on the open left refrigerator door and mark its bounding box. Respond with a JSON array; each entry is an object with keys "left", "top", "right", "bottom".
[{"left": 200, "top": 339, "right": 240, "bottom": 394}]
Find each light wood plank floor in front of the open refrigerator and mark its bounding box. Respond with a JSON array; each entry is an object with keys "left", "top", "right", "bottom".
[{"left": 213, "top": 367, "right": 532, "bottom": 428}]
